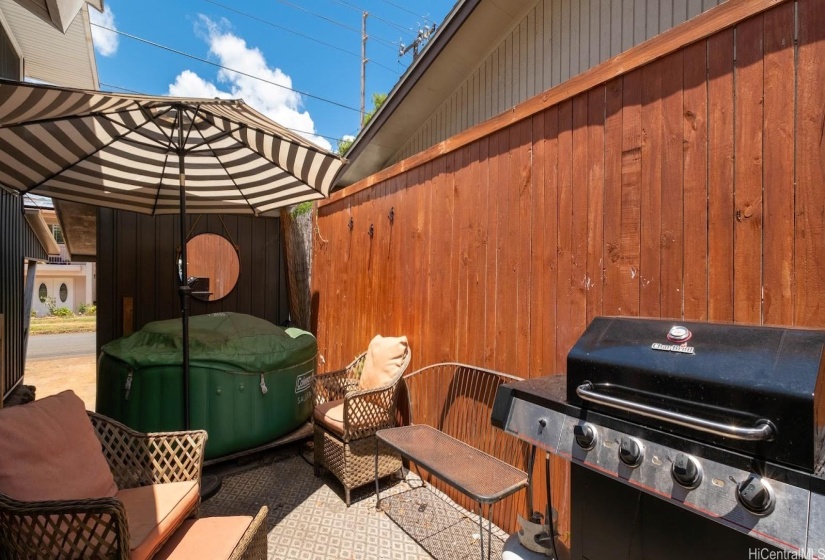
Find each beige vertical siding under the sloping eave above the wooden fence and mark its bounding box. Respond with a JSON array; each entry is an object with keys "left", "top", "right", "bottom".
[{"left": 388, "top": 0, "right": 724, "bottom": 164}]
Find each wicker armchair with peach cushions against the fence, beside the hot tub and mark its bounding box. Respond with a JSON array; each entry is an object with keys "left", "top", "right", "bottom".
[{"left": 313, "top": 336, "right": 411, "bottom": 506}]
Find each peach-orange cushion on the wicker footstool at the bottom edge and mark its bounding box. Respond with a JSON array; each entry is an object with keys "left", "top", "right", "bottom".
[{"left": 155, "top": 516, "right": 252, "bottom": 560}]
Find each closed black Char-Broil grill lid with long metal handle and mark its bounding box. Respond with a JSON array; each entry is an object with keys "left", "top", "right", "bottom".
[{"left": 567, "top": 317, "right": 825, "bottom": 472}]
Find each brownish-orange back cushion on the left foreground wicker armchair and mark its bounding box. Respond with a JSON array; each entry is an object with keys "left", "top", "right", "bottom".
[{"left": 0, "top": 391, "right": 117, "bottom": 502}]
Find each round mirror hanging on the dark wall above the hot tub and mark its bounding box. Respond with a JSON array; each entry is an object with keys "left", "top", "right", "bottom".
[{"left": 186, "top": 233, "right": 240, "bottom": 301}]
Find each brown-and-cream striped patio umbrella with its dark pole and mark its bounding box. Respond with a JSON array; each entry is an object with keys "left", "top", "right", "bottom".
[{"left": 0, "top": 80, "right": 344, "bottom": 428}]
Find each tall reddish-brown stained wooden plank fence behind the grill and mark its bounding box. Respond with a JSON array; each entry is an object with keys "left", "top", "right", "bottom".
[{"left": 313, "top": 0, "right": 825, "bottom": 544}]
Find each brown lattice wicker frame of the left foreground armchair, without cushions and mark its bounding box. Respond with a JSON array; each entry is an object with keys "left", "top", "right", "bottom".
[{"left": 0, "top": 412, "right": 206, "bottom": 560}]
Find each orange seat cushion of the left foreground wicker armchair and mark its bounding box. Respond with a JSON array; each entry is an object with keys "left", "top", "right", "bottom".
[{"left": 115, "top": 481, "right": 200, "bottom": 560}]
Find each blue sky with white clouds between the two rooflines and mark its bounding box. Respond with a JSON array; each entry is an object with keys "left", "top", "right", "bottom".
[{"left": 89, "top": 0, "right": 454, "bottom": 150}]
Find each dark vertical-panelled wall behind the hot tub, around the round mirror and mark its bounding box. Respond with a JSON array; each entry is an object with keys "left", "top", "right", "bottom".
[{"left": 97, "top": 208, "right": 289, "bottom": 352}]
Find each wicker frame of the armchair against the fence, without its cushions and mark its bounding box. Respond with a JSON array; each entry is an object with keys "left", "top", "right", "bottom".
[{"left": 313, "top": 342, "right": 411, "bottom": 507}]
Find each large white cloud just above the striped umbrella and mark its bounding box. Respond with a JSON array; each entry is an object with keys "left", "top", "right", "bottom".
[{"left": 169, "top": 15, "right": 332, "bottom": 150}]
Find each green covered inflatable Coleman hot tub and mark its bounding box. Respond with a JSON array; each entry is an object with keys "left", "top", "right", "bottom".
[{"left": 96, "top": 313, "right": 318, "bottom": 459}]
